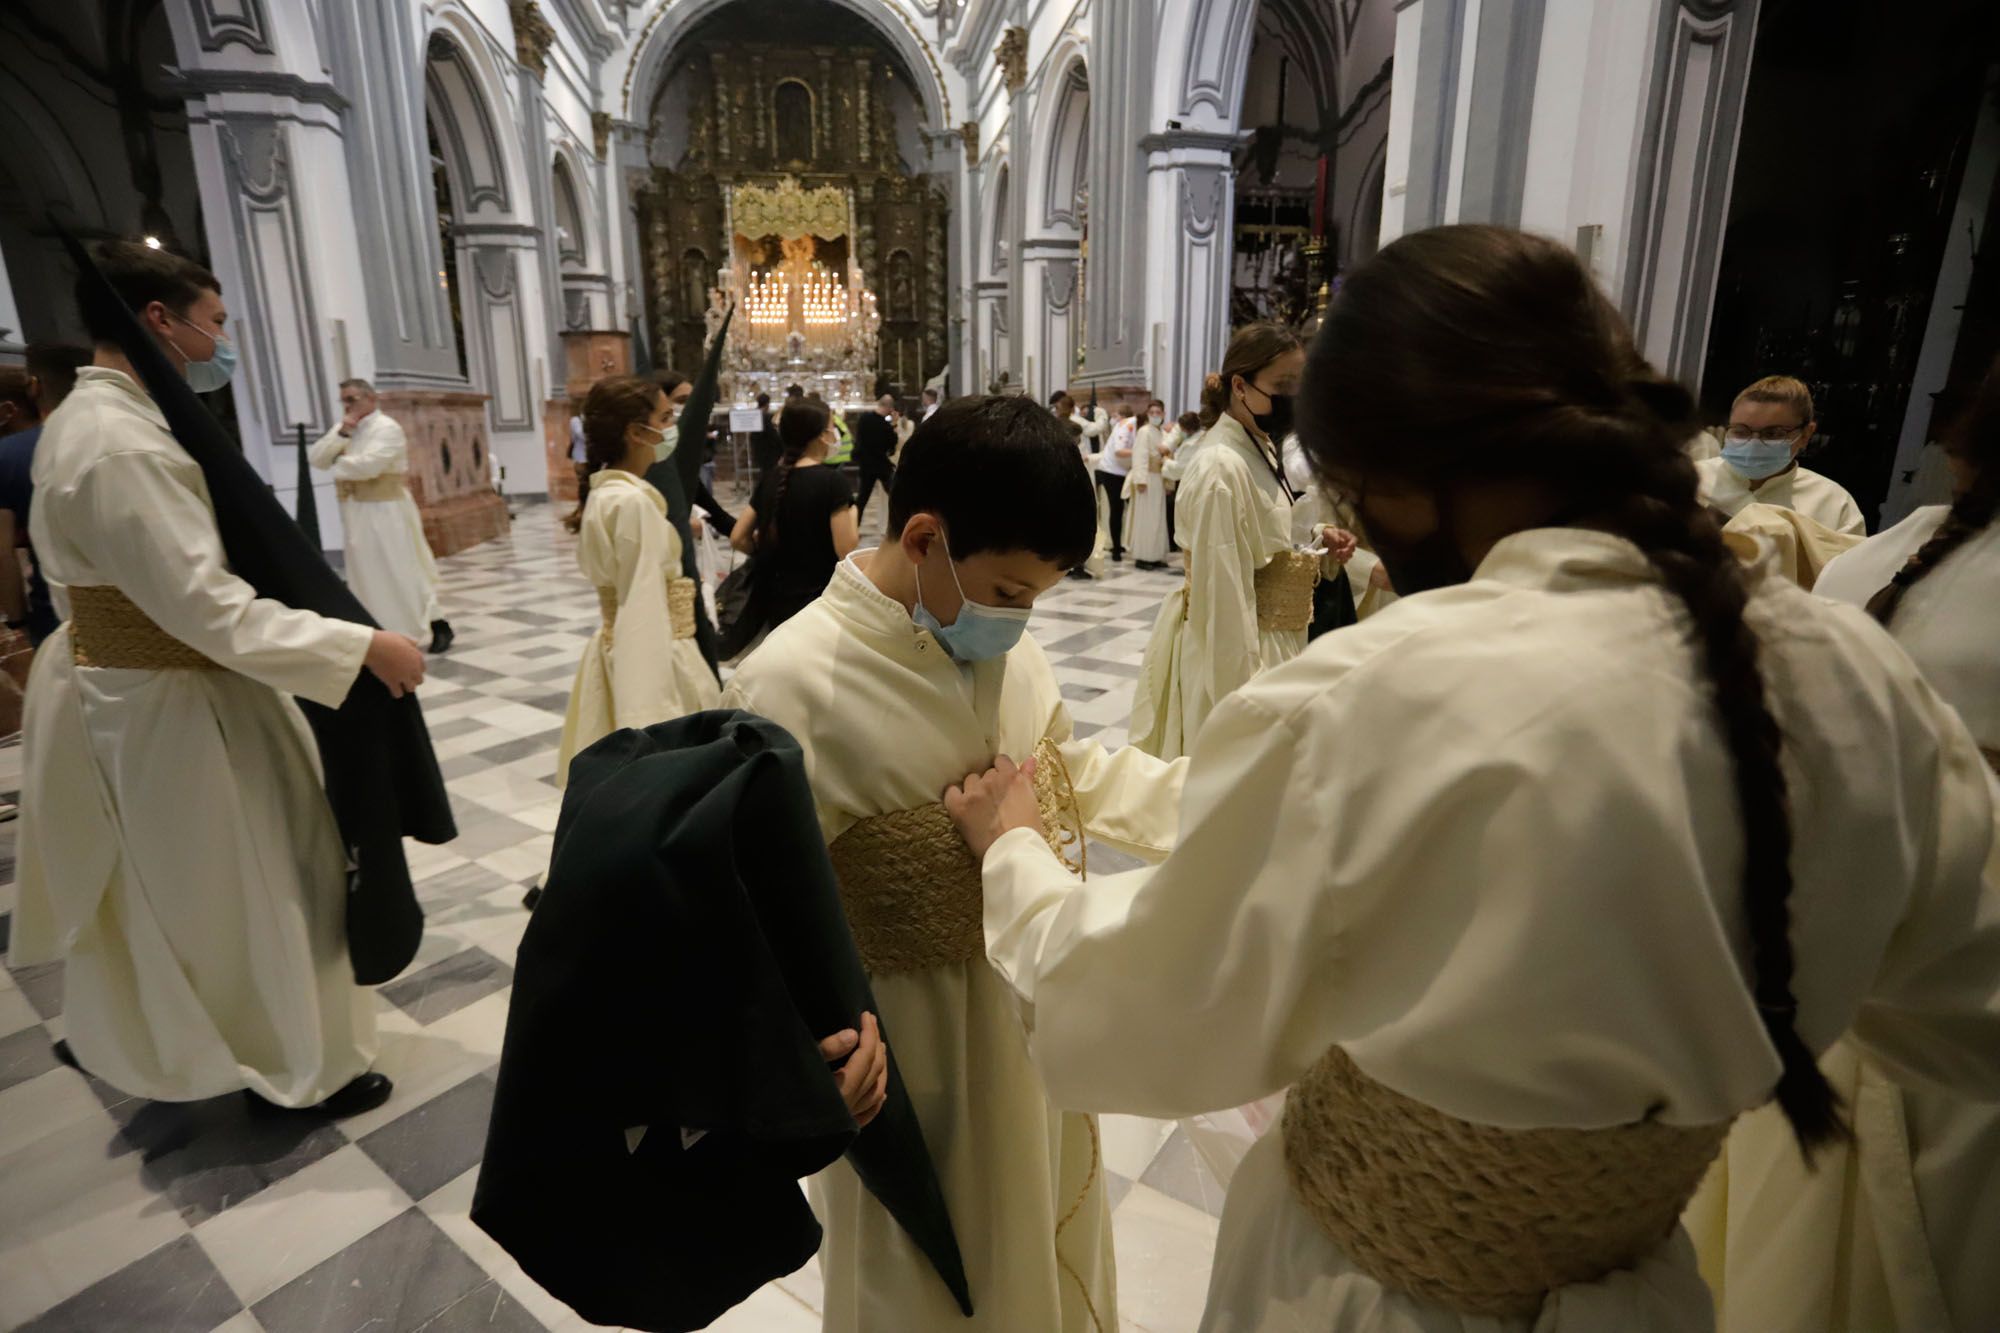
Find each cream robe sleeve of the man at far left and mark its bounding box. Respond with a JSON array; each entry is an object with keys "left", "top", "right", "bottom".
[{"left": 76, "top": 450, "right": 374, "bottom": 709}]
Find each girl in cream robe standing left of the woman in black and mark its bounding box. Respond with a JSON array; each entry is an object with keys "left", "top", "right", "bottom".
[{"left": 556, "top": 376, "right": 722, "bottom": 785}]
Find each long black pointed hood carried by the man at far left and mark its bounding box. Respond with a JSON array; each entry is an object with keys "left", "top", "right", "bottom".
[{"left": 62, "top": 232, "right": 458, "bottom": 985}]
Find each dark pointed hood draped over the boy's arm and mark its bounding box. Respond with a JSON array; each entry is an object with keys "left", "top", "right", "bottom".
[{"left": 472, "top": 713, "right": 972, "bottom": 1333}]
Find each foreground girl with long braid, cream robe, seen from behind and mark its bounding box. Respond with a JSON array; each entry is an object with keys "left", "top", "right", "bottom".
[{"left": 946, "top": 228, "right": 2000, "bottom": 1333}]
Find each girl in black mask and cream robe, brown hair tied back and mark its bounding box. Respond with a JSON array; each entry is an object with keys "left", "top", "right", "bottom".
[{"left": 1132, "top": 324, "right": 1352, "bottom": 759}]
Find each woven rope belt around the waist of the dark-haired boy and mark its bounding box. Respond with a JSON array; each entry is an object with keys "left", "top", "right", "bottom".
[{"left": 828, "top": 739, "right": 1086, "bottom": 977}]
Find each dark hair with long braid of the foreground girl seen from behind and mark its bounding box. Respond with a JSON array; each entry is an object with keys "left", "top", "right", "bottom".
[{"left": 1300, "top": 226, "right": 1848, "bottom": 1159}]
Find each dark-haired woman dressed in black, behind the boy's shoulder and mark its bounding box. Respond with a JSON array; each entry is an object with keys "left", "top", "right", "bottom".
[{"left": 730, "top": 402, "right": 860, "bottom": 628}]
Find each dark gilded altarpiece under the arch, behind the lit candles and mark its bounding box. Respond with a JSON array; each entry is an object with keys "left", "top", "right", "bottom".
[{"left": 638, "top": 42, "right": 948, "bottom": 392}]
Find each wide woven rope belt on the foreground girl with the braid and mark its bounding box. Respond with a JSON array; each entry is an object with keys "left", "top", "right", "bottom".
[{"left": 1284, "top": 1047, "right": 1730, "bottom": 1317}]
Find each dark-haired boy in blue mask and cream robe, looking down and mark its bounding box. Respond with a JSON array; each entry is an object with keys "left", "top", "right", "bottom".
[{"left": 724, "top": 396, "right": 1184, "bottom": 1333}]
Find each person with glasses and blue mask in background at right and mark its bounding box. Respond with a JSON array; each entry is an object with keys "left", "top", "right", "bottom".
[{"left": 1694, "top": 374, "right": 1868, "bottom": 536}]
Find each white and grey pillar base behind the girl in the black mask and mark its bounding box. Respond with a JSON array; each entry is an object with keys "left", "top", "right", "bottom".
[{"left": 1140, "top": 130, "right": 1246, "bottom": 410}]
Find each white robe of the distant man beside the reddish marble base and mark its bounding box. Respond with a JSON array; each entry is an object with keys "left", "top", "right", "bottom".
[{"left": 306, "top": 410, "right": 442, "bottom": 640}]
